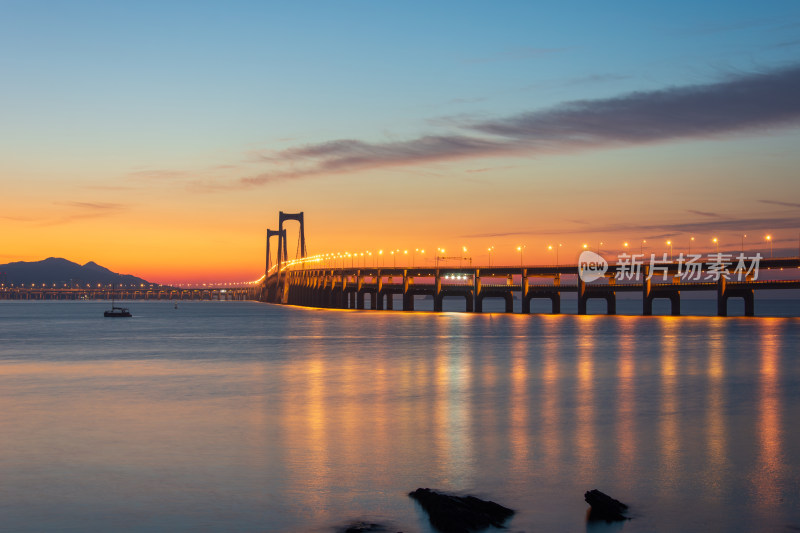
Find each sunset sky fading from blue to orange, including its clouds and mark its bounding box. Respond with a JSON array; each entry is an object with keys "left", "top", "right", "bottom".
[{"left": 0, "top": 0, "right": 800, "bottom": 283}]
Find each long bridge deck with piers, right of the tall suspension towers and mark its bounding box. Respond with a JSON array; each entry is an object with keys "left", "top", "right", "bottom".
[{"left": 260, "top": 257, "right": 800, "bottom": 316}]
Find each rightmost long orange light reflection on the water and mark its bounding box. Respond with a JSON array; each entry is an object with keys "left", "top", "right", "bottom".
[{"left": 753, "top": 320, "right": 785, "bottom": 508}]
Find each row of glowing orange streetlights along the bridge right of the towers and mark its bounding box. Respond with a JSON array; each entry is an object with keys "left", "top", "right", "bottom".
[{"left": 272, "top": 234, "right": 784, "bottom": 274}]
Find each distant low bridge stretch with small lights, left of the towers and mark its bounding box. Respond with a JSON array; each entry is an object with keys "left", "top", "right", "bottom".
[{"left": 0, "top": 286, "right": 260, "bottom": 300}]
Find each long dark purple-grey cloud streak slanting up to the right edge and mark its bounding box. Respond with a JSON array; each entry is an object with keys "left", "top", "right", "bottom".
[{"left": 230, "top": 65, "right": 800, "bottom": 187}]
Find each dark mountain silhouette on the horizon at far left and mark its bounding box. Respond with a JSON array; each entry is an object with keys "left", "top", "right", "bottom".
[{"left": 0, "top": 257, "right": 149, "bottom": 285}]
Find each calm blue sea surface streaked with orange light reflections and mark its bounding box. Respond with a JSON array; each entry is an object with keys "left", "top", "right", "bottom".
[{"left": 0, "top": 302, "right": 800, "bottom": 533}]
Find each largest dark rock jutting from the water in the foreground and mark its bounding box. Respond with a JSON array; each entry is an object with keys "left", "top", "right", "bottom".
[{"left": 408, "top": 489, "right": 514, "bottom": 533}]
